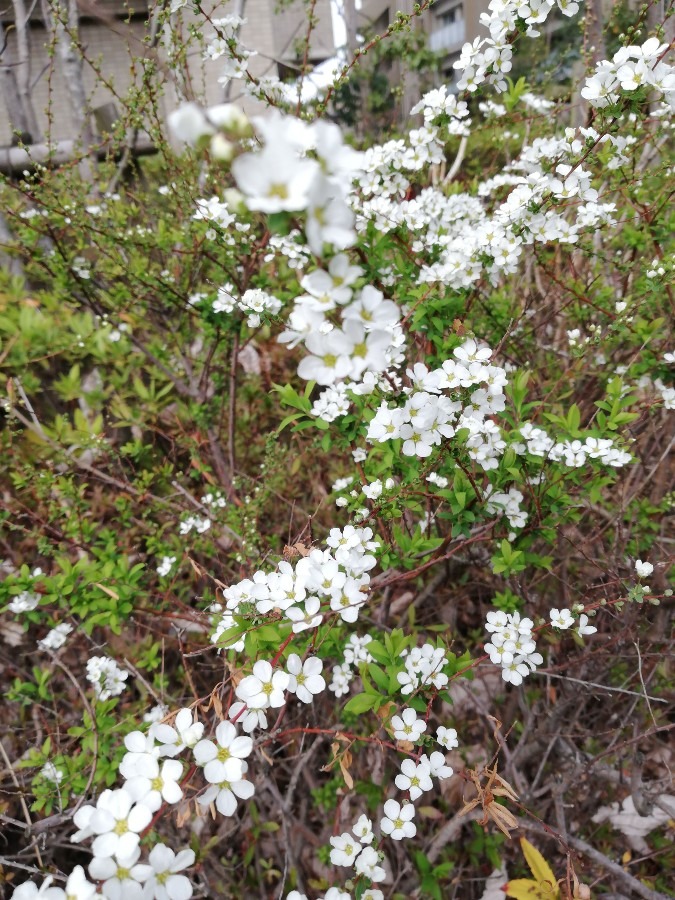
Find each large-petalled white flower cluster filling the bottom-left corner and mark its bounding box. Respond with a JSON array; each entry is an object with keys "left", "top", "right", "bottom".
[{"left": 13, "top": 709, "right": 217, "bottom": 900}]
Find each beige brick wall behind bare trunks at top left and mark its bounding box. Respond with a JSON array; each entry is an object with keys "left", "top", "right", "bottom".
[{"left": 0, "top": 0, "right": 334, "bottom": 146}]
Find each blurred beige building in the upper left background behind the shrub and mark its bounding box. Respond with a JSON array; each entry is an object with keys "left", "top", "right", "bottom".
[{"left": 0, "top": 0, "right": 335, "bottom": 147}]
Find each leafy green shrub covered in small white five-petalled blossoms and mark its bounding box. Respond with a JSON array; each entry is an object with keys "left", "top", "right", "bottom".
[{"left": 0, "top": 0, "right": 675, "bottom": 900}]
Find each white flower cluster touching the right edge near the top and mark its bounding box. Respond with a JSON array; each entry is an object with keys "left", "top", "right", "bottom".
[{"left": 581, "top": 37, "right": 675, "bottom": 110}]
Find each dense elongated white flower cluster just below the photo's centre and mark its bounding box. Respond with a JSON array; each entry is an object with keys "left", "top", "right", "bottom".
[{"left": 211, "top": 525, "right": 378, "bottom": 664}]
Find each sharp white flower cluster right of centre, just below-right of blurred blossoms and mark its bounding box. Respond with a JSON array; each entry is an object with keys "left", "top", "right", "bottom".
[{"left": 367, "top": 338, "right": 506, "bottom": 469}]
